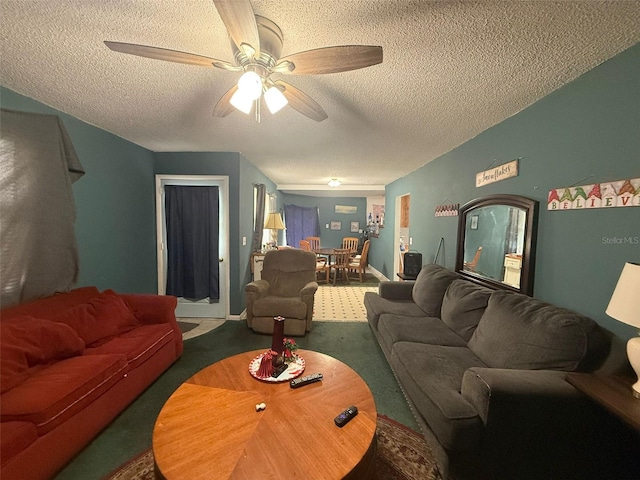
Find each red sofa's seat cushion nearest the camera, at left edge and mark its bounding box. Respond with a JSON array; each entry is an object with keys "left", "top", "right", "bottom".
[{"left": 0, "top": 355, "right": 128, "bottom": 435}]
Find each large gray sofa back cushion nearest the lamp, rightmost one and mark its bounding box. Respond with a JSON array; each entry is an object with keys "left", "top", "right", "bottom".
[{"left": 469, "top": 291, "right": 606, "bottom": 371}]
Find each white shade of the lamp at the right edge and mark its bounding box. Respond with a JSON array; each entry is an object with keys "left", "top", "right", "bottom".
[{"left": 606, "top": 262, "right": 640, "bottom": 328}]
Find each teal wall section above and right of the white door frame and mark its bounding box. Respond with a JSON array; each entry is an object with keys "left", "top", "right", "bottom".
[{"left": 154, "top": 152, "right": 275, "bottom": 315}]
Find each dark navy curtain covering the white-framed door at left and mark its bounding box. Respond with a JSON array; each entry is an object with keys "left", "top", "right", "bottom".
[{"left": 164, "top": 185, "right": 220, "bottom": 303}]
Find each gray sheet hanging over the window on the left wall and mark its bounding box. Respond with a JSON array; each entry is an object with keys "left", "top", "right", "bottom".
[{"left": 0, "top": 109, "right": 84, "bottom": 308}]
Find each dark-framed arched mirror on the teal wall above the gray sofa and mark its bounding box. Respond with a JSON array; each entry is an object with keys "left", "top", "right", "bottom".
[{"left": 456, "top": 195, "right": 538, "bottom": 295}]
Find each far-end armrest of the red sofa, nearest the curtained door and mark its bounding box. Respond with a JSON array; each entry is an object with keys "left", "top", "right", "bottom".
[{"left": 119, "top": 293, "right": 183, "bottom": 357}]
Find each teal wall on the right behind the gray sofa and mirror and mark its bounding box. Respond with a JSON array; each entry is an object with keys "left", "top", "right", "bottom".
[{"left": 370, "top": 44, "right": 640, "bottom": 338}]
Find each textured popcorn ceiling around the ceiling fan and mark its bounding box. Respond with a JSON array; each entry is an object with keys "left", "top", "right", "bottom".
[{"left": 0, "top": 0, "right": 640, "bottom": 195}]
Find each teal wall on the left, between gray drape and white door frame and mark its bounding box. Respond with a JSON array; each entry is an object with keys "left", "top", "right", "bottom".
[{"left": 0, "top": 87, "right": 157, "bottom": 293}]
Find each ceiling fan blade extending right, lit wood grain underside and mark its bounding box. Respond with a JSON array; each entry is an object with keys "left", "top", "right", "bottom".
[{"left": 273, "top": 45, "right": 382, "bottom": 75}]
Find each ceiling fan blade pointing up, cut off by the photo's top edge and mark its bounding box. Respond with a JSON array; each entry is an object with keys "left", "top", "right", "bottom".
[{"left": 213, "top": 0, "right": 260, "bottom": 57}]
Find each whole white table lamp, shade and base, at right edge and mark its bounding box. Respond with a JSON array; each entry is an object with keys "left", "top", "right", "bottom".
[{"left": 606, "top": 262, "right": 640, "bottom": 399}]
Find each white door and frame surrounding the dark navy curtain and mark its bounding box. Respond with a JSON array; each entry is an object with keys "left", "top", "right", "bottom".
[{"left": 156, "top": 175, "right": 229, "bottom": 319}]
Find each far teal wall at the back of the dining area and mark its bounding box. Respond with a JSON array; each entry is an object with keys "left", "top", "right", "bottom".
[{"left": 283, "top": 194, "right": 367, "bottom": 247}]
